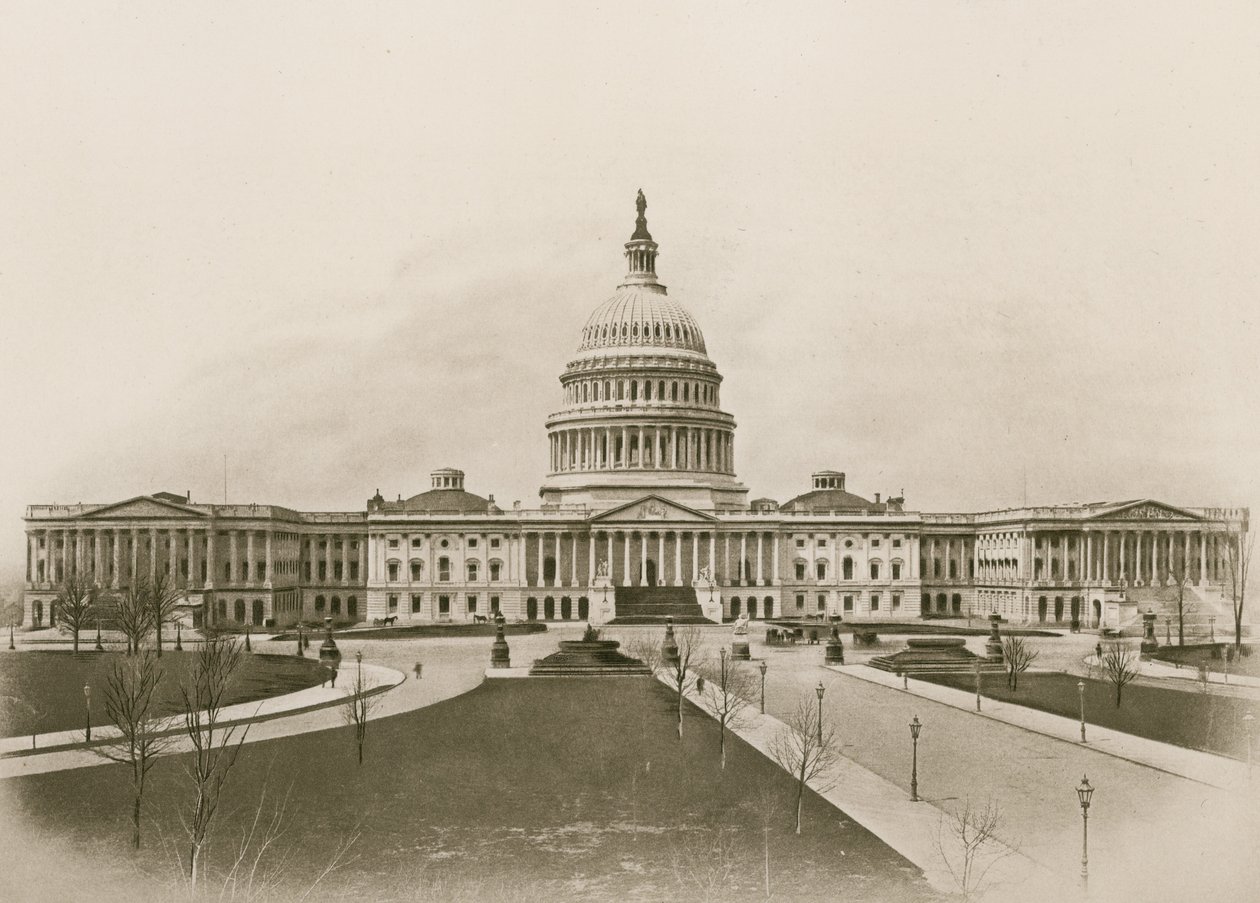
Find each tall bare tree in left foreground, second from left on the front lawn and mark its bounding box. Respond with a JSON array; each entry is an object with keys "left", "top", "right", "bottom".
[{"left": 179, "top": 637, "right": 249, "bottom": 888}]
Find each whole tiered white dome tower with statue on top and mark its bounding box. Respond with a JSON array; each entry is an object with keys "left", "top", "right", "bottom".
[{"left": 539, "top": 191, "right": 747, "bottom": 511}]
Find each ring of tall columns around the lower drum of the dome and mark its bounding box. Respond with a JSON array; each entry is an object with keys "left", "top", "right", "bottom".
[{"left": 551, "top": 426, "right": 735, "bottom": 474}]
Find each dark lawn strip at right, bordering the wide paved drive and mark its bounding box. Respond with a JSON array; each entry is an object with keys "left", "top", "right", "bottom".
[{"left": 922, "top": 674, "right": 1255, "bottom": 758}]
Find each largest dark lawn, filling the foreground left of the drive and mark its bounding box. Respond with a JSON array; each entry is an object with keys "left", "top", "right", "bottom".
[{"left": 4, "top": 678, "right": 939, "bottom": 903}]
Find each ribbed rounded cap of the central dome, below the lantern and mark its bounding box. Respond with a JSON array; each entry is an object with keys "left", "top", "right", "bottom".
[{"left": 577, "top": 286, "right": 706, "bottom": 354}]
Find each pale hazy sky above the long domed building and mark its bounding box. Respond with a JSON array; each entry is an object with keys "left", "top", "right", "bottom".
[{"left": 0, "top": 0, "right": 1260, "bottom": 578}]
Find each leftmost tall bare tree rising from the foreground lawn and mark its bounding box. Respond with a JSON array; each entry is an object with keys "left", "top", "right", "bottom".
[{"left": 92, "top": 650, "right": 170, "bottom": 850}]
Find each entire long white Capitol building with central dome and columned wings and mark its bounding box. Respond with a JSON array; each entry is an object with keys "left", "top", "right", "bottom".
[{"left": 24, "top": 193, "right": 1247, "bottom": 627}]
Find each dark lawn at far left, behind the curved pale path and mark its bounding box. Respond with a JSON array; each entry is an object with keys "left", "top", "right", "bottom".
[{"left": 0, "top": 644, "right": 326, "bottom": 737}]
